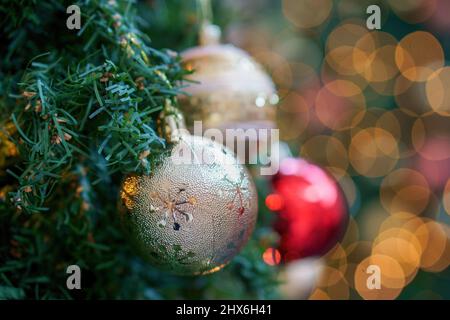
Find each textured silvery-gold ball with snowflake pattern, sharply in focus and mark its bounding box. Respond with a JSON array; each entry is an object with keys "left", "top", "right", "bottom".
[{"left": 120, "top": 103, "right": 257, "bottom": 275}]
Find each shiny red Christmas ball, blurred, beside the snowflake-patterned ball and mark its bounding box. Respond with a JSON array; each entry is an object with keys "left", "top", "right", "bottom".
[{"left": 266, "top": 158, "right": 348, "bottom": 262}]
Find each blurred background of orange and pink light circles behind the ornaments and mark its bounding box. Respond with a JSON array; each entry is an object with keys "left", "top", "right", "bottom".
[{"left": 141, "top": 0, "right": 450, "bottom": 299}]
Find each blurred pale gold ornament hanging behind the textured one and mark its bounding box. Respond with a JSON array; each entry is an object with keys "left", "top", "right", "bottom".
[{"left": 179, "top": 23, "right": 278, "bottom": 131}]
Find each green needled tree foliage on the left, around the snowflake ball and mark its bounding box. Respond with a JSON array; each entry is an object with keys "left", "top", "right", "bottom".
[{"left": 0, "top": 0, "right": 275, "bottom": 299}]
